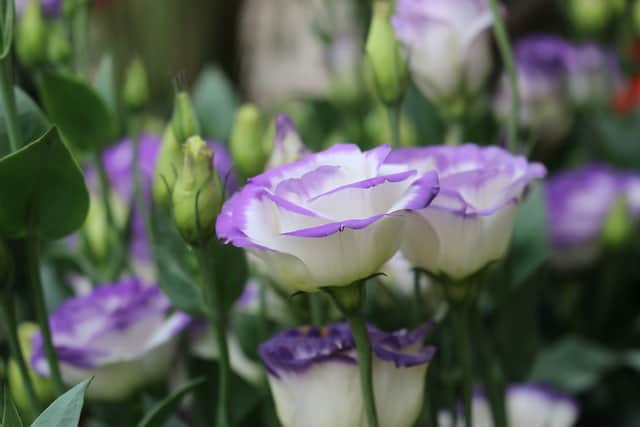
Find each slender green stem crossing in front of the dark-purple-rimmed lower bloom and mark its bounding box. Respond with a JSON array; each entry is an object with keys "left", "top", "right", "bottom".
[{"left": 346, "top": 313, "right": 378, "bottom": 427}]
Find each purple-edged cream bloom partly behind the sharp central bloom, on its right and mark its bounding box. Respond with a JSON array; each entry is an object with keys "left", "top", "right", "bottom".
[{"left": 387, "top": 144, "right": 546, "bottom": 279}]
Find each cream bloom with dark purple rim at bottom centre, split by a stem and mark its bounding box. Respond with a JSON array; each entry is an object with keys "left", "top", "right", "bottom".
[{"left": 259, "top": 323, "right": 435, "bottom": 427}]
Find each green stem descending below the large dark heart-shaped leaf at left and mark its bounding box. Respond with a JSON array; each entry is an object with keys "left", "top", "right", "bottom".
[{"left": 26, "top": 237, "right": 65, "bottom": 394}]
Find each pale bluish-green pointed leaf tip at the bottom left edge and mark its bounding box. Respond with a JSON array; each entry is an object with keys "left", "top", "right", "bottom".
[{"left": 31, "top": 377, "right": 93, "bottom": 427}]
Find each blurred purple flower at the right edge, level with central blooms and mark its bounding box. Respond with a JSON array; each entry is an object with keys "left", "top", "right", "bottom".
[{"left": 545, "top": 164, "right": 640, "bottom": 268}]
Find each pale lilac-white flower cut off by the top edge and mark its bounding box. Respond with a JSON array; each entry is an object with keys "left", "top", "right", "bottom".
[{"left": 393, "top": 0, "right": 493, "bottom": 105}]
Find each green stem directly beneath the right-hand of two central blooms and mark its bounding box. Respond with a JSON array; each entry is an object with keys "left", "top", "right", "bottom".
[{"left": 451, "top": 304, "right": 473, "bottom": 427}]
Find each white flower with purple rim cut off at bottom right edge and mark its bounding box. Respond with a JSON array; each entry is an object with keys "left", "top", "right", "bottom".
[{"left": 438, "top": 384, "right": 578, "bottom": 427}]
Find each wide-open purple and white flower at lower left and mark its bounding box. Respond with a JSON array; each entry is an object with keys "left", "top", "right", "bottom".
[{"left": 31, "top": 279, "right": 190, "bottom": 400}]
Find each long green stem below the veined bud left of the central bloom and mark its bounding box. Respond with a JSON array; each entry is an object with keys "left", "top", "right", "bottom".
[{"left": 196, "top": 244, "right": 231, "bottom": 427}]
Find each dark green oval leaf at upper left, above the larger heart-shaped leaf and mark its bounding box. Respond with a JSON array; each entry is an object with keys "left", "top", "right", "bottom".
[{"left": 38, "top": 72, "right": 116, "bottom": 154}]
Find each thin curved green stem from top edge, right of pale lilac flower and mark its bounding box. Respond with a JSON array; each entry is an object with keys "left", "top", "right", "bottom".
[{"left": 489, "top": 0, "right": 520, "bottom": 152}]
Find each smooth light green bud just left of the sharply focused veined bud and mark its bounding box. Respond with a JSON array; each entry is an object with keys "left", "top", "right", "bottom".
[{"left": 152, "top": 126, "right": 182, "bottom": 209}]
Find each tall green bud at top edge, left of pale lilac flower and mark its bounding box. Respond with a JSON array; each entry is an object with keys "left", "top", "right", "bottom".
[{"left": 365, "top": 1, "right": 409, "bottom": 104}]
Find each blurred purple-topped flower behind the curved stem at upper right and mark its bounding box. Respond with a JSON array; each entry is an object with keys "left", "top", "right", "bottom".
[{"left": 495, "top": 35, "right": 575, "bottom": 142}]
